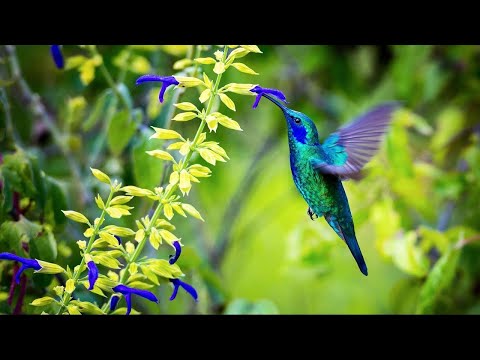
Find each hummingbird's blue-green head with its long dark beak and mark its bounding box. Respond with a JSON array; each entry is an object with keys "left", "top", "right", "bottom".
[{"left": 262, "top": 94, "right": 319, "bottom": 145}]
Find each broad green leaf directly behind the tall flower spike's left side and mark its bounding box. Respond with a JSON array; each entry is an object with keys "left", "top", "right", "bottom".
[{"left": 131, "top": 129, "right": 164, "bottom": 189}]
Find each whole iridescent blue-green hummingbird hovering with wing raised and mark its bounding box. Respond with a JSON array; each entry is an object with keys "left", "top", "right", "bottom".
[{"left": 262, "top": 93, "right": 399, "bottom": 276}]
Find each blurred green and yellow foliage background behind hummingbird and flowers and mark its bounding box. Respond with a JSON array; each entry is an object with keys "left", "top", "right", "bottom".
[{"left": 0, "top": 45, "right": 480, "bottom": 314}]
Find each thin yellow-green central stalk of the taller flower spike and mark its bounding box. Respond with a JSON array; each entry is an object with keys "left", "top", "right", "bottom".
[{"left": 102, "top": 46, "right": 228, "bottom": 311}]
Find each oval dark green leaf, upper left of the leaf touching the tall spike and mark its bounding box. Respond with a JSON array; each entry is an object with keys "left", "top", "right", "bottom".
[{"left": 107, "top": 109, "right": 137, "bottom": 156}]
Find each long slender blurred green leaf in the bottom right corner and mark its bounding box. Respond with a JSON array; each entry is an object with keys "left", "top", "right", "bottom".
[{"left": 416, "top": 249, "right": 461, "bottom": 314}]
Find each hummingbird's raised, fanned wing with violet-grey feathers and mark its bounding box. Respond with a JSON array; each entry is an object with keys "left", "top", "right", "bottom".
[{"left": 311, "top": 102, "right": 400, "bottom": 179}]
